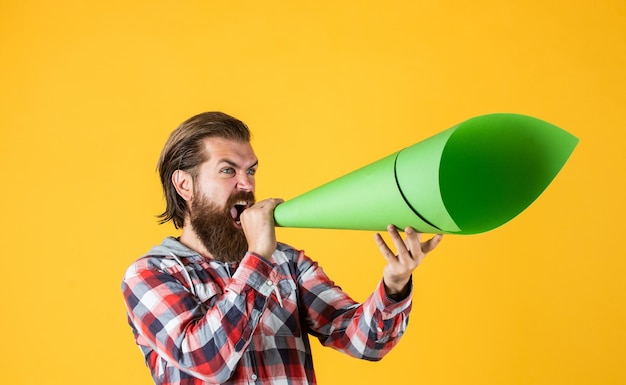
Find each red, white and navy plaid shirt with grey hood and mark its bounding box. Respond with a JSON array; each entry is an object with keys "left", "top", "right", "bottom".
[{"left": 122, "top": 238, "right": 411, "bottom": 384}]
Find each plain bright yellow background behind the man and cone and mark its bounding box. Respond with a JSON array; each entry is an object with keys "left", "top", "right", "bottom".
[{"left": 0, "top": 0, "right": 626, "bottom": 385}]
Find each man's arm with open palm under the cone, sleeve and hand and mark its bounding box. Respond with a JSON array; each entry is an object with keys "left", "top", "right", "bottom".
[{"left": 298, "top": 228, "right": 441, "bottom": 360}]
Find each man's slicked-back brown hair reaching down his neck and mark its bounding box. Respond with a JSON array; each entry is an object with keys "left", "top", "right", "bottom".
[{"left": 157, "top": 112, "right": 250, "bottom": 229}]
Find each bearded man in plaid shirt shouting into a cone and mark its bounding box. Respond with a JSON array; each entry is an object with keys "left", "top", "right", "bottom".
[{"left": 122, "top": 112, "right": 441, "bottom": 384}]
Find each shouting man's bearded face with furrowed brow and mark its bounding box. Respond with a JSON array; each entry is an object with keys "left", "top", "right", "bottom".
[{"left": 190, "top": 138, "right": 258, "bottom": 262}]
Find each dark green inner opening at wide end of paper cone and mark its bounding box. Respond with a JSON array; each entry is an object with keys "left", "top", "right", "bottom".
[{"left": 439, "top": 114, "right": 578, "bottom": 234}]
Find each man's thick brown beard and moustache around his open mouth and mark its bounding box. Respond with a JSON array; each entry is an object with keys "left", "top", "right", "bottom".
[{"left": 190, "top": 191, "right": 254, "bottom": 263}]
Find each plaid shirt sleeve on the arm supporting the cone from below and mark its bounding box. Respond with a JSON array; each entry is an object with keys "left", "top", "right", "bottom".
[{"left": 298, "top": 252, "right": 413, "bottom": 361}]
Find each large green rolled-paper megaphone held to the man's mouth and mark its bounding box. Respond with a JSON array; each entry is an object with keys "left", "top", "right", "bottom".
[{"left": 274, "top": 113, "right": 578, "bottom": 234}]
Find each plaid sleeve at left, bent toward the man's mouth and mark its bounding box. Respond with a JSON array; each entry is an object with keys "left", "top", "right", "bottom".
[{"left": 122, "top": 253, "right": 282, "bottom": 383}]
